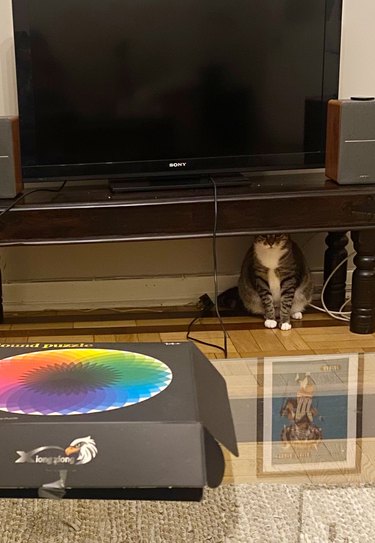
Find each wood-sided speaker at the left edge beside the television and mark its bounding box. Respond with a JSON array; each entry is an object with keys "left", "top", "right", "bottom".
[{"left": 0, "top": 117, "right": 23, "bottom": 198}]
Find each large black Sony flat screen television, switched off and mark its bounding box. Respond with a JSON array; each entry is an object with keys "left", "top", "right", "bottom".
[{"left": 13, "top": 0, "right": 342, "bottom": 188}]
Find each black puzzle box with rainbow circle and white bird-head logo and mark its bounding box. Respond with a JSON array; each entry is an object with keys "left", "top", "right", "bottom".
[{"left": 0, "top": 342, "right": 238, "bottom": 499}]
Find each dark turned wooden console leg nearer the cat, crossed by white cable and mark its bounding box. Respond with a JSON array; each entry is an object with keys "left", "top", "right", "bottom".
[{"left": 324, "top": 232, "right": 348, "bottom": 311}]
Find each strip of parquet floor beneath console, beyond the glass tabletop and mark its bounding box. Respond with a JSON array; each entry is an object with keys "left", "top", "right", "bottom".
[{"left": 0, "top": 310, "right": 375, "bottom": 359}]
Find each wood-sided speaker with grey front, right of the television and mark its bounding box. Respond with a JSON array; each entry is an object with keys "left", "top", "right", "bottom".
[{"left": 326, "top": 98, "right": 375, "bottom": 185}]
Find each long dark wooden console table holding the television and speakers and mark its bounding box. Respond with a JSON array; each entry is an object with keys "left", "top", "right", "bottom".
[{"left": 0, "top": 173, "right": 375, "bottom": 334}]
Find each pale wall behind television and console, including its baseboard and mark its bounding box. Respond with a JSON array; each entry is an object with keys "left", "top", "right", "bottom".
[{"left": 0, "top": 0, "right": 375, "bottom": 310}]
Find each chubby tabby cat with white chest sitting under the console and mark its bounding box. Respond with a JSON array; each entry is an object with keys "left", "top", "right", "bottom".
[{"left": 238, "top": 234, "right": 313, "bottom": 330}]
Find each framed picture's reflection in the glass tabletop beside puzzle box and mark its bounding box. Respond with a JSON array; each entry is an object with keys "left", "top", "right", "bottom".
[{"left": 257, "top": 353, "right": 362, "bottom": 475}]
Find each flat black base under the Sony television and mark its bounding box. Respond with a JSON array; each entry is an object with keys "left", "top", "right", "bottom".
[{"left": 108, "top": 173, "right": 249, "bottom": 194}]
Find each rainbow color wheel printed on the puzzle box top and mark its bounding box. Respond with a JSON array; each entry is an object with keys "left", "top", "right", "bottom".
[{"left": 0, "top": 348, "right": 173, "bottom": 415}]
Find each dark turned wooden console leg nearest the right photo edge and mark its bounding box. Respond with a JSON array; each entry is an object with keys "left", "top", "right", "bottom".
[{"left": 350, "top": 230, "right": 375, "bottom": 334}]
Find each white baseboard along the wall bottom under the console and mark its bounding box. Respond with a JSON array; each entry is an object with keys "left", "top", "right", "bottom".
[{"left": 3, "top": 271, "right": 352, "bottom": 311}]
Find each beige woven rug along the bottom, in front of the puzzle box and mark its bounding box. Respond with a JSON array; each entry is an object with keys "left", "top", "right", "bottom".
[{"left": 0, "top": 483, "right": 375, "bottom": 543}]
